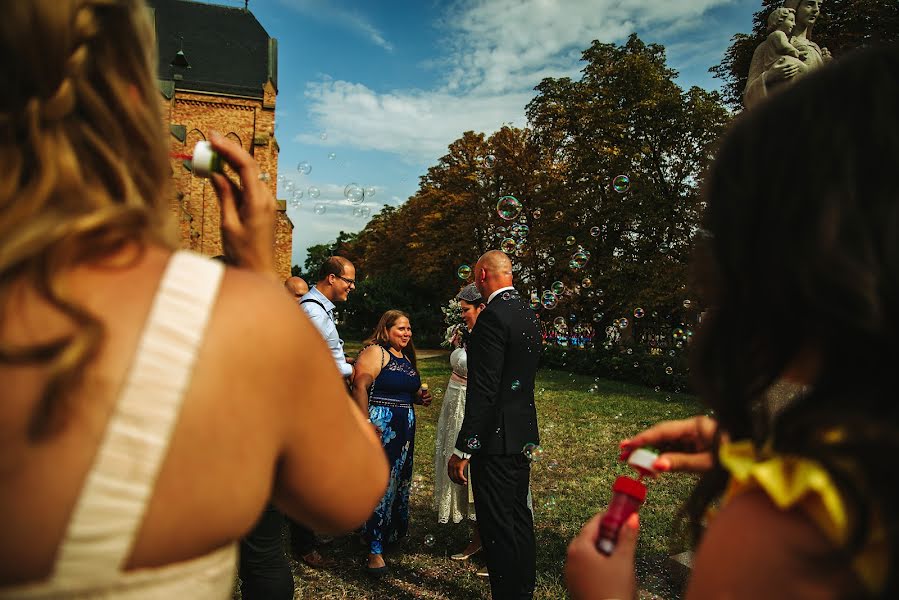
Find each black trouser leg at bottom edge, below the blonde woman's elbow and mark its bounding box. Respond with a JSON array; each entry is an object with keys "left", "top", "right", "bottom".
[{"left": 240, "top": 504, "right": 293, "bottom": 600}]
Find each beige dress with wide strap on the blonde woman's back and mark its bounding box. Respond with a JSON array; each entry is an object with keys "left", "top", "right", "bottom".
[{"left": 0, "top": 252, "right": 237, "bottom": 600}]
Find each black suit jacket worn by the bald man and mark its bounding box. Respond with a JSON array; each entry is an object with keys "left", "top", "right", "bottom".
[{"left": 456, "top": 290, "right": 542, "bottom": 454}]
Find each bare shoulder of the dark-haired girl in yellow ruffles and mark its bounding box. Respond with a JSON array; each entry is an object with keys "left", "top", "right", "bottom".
[{"left": 687, "top": 490, "right": 859, "bottom": 599}]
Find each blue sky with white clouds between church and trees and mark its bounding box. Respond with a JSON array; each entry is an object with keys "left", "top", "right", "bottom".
[{"left": 216, "top": 0, "right": 761, "bottom": 265}]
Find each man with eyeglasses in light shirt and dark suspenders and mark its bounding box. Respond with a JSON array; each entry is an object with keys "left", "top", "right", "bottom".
[{"left": 290, "top": 256, "right": 356, "bottom": 568}]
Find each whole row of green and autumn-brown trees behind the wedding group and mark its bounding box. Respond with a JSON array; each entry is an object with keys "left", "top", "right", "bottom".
[{"left": 326, "top": 35, "right": 729, "bottom": 344}]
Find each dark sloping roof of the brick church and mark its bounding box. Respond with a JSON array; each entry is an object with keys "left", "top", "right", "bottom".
[{"left": 147, "top": 0, "right": 278, "bottom": 98}]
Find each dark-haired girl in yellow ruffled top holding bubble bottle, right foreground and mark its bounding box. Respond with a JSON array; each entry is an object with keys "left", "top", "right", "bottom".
[{"left": 566, "top": 45, "right": 899, "bottom": 599}]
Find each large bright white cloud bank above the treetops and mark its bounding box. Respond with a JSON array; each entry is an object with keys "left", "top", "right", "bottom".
[{"left": 298, "top": 0, "right": 734, "bottom": 164}]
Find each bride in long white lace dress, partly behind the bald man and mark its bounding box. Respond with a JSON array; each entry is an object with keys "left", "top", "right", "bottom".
[{"left": 434, "top": 284, "right": 486, "bottom": 560}]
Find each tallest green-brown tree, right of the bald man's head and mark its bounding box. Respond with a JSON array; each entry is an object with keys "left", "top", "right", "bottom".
[{"left": 527, "top": 35, "right": 729, "bottom": 324}]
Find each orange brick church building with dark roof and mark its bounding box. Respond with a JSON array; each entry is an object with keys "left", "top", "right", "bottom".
[{"left": 147, "top": 0, "right": 293, "bottom": 278}]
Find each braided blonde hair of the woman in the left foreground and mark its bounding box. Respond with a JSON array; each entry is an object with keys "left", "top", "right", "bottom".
[{"left": 0, "top": 0, "right": 175, "bottom": 439}]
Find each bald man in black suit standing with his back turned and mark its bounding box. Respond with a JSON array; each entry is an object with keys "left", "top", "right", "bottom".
[{"left": 447, "top": 250, "right": 541, "bottom": 600}]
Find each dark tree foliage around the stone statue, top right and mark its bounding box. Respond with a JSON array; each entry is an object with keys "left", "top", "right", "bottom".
[{"left": 709, "top": 0, "right": 899, "bottom": 110}]
